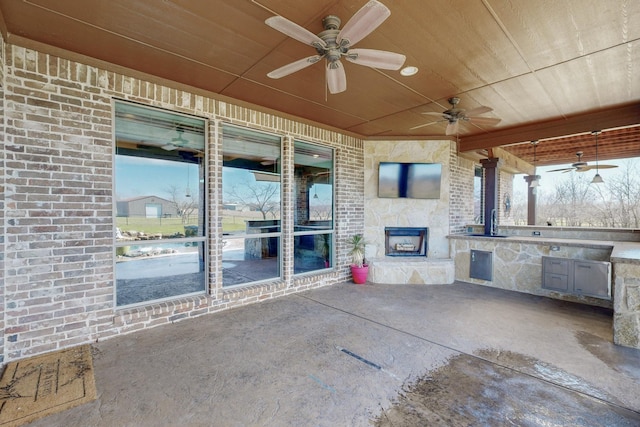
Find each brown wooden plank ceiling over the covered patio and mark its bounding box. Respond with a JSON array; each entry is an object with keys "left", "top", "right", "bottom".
[{"left": 0, "top": 0, "right": 640, "bottom": 171}]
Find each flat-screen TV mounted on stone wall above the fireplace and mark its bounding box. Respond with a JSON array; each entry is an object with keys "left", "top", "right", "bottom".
[{"left": 378, "top": 162, "right": 442, "bottom": 199}]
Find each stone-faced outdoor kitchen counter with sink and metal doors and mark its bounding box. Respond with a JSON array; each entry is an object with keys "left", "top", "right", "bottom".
[{"left": 448, "top": 234, "right": 640, "bottom": 349}]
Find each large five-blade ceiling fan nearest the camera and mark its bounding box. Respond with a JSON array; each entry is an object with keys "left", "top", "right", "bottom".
[{"left": 265, "top": 0, "right": 406, "bottom": 94}]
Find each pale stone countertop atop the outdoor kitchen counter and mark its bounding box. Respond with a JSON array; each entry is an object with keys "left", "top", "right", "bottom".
[{"left": 447, "top": 234, "right": 640, "bottom": 264}]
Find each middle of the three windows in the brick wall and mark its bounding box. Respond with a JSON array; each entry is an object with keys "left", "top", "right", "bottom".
[{"left": 222, "top": 125, "right": 282, "bottom": 287}]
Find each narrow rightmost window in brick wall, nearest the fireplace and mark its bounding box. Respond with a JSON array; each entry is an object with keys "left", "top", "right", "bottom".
[{"left": 293, "top": 141, "right": 333, "bottom": 274}]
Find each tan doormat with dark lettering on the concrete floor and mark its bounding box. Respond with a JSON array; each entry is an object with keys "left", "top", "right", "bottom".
[{"left": 0, "top": 345, "right": 96, "bottom": 427}]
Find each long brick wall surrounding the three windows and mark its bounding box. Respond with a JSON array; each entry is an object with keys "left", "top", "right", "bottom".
[{"left": 0, "top": 44, "right": 364, "bottom": 362}]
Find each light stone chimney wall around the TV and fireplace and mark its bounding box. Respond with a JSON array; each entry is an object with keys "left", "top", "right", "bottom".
[{"left": 364, "top": 140, "right": 454, "bottom": 258}]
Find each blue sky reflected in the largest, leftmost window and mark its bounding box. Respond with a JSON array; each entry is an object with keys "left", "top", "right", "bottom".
[{"left": 115, "top": 155, "right": 199, "bottom": 200}]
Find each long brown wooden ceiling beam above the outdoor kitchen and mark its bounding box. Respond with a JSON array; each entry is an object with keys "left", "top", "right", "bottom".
[{"left": 459, "top": 103, "right": 640, "bottom": 152}]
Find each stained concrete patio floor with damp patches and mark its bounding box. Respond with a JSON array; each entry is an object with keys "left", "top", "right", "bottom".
[{"left": 25, "top": 283, "right": 640, "bottom": 427}]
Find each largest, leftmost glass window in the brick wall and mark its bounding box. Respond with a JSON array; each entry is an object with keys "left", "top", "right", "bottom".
[{"left": 114, "top": 102, "right": 206, "bottom": 306}]
